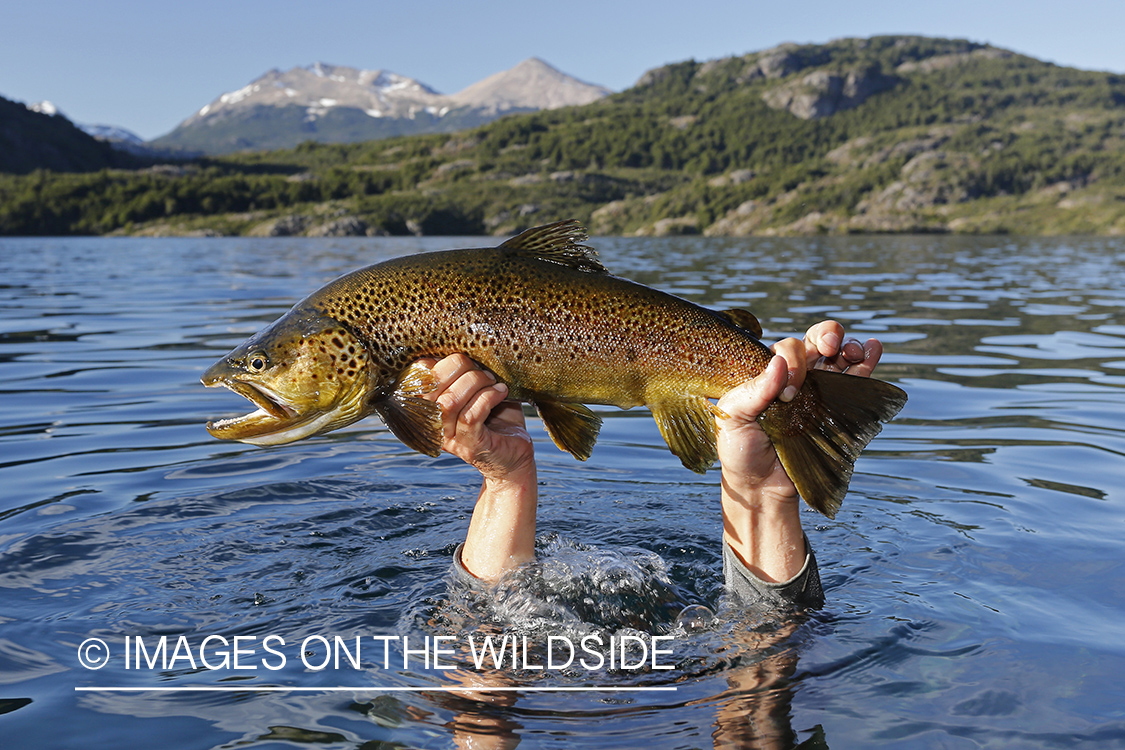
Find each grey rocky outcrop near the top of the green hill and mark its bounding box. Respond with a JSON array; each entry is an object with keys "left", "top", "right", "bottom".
[{"left": 762, "top": 67, "right": 899, "bottom": 120}]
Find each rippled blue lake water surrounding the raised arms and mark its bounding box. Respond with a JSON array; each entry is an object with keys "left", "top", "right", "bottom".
[{"left": 0, "top": 236, "right": 1125, "bottom": 750}]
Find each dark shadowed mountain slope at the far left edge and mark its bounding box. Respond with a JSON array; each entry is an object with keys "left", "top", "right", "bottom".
[{"left": 0, "top": 98, "right": 126, "bottom": 174}]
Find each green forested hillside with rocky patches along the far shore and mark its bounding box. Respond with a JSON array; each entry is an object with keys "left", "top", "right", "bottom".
[{"left": 0, "top": 37, "right": 1125, "bottom": 235}]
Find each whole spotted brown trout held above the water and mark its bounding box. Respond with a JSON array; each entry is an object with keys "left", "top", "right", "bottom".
[{"left": 201, "top": 219, "right": 907, "bottom": 518}]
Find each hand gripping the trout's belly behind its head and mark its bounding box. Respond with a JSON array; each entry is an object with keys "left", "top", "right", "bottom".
[{"left": 421, "top": 354, "right": 534, "bottom": 480}]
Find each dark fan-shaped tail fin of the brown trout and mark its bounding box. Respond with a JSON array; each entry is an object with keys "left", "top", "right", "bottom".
[{"left": 759, "top": 370, "right": 907, "bottom": 518}]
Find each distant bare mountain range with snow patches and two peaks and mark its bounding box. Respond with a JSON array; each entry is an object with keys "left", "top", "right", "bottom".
[{"left": 152, "top": 58, "right": 609, "bottom": 154}]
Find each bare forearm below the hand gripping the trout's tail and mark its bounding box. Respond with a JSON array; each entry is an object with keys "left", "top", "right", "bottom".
[{"left": 722, "top": 471, "right": 808, "bottom": 582}]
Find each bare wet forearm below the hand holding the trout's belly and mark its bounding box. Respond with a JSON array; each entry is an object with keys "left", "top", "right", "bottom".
[{"left": 461, "top": 462, "right": 539, "bottom": 581}]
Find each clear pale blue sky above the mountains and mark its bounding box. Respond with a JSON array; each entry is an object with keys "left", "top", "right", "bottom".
[{"left": 0, "top": 0, "right": 1125, "bottom": 138}]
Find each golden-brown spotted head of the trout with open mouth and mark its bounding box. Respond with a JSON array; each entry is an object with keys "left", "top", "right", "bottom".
[{"left": 201, "top": 309, "right": 371, "bottom": 445}]
